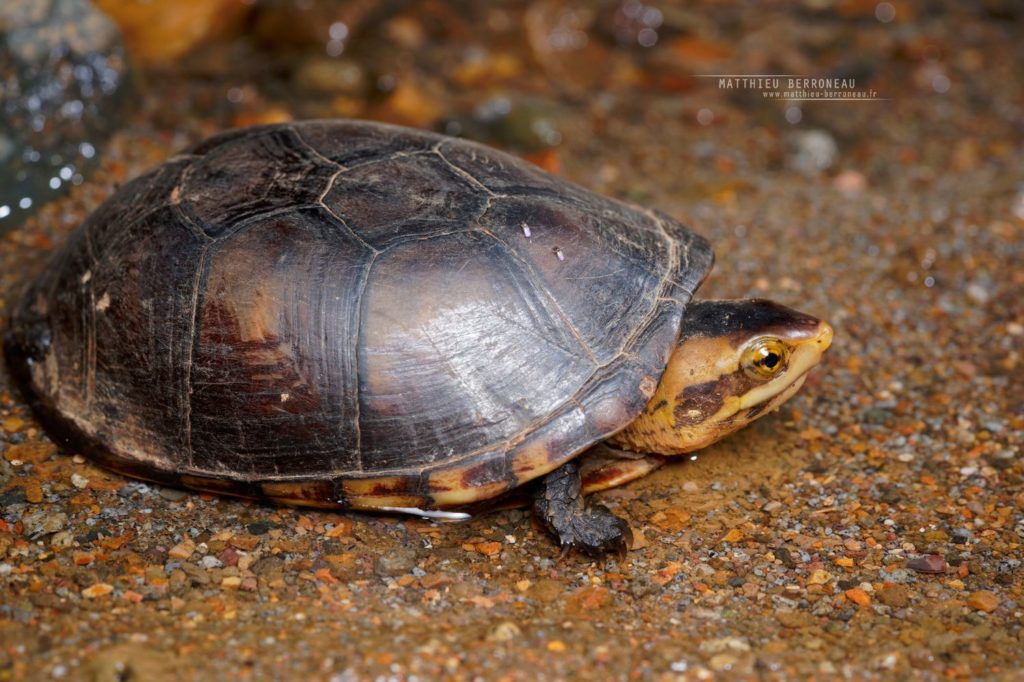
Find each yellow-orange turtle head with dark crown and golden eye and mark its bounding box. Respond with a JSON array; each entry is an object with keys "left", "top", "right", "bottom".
[{"left": 614, "top": 299, "right": 833, "bottom": 455}]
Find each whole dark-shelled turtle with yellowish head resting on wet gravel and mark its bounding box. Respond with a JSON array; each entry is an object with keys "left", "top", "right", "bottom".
[{"left": 4, "top": 120, "right": 833, "bottom": 554}]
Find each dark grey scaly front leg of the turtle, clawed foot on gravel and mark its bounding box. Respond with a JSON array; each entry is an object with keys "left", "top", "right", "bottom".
[{"left": 534, "top": 460, "right": 633, "bottom": 556}]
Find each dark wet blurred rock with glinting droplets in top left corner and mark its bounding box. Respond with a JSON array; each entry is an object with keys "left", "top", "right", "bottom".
[{"left": 0, "top": 0, "right": 129, "bottom": 231}]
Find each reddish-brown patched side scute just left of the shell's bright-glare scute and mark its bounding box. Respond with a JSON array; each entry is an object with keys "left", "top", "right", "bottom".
[{"left": 189, "top": 208, "right": 373, "bottom": 476}]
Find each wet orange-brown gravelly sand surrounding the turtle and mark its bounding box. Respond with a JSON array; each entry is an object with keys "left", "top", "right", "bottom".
[{"left": 0, "top": 2, "right": 1024, "bottom": 680}]
